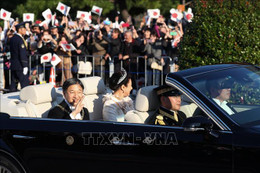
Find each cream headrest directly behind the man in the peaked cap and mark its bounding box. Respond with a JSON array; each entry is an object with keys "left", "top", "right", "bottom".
[{"left": 135, "top": 86, "right": 160, "bottom": 112}]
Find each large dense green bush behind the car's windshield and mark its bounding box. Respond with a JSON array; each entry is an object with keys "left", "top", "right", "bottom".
[{"left": 179, "top": 0, "right": 260, "bottom": 68}]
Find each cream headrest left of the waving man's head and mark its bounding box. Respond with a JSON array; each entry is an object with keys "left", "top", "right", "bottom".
[{"left": 20, "top": 84, "right": 57, "bottom": 104}]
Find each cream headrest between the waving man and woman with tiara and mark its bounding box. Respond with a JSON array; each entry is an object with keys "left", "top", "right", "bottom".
[{"left": 80, "top": 76, "right": 106, "bottom": 95}]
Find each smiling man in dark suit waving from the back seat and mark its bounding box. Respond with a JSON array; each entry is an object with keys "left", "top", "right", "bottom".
[{"left": 48, "top": 78, "right": 89, "bottom": 120}]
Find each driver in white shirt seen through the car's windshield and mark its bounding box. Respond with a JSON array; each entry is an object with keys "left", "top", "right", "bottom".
[{"left": 206, "top": 76, "right": 234, "bottom": 115}]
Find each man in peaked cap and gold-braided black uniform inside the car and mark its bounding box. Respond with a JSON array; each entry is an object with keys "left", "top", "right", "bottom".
[{"left": 150, "top": 85, "right": 186, "bottom": 126}]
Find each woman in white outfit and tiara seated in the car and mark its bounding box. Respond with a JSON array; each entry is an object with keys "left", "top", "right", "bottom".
[{"left": 103, "top": 70, "right": 134, "bottom": 122}]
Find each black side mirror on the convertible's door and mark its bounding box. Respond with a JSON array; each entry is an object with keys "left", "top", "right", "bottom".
[{"left": 182, "top": 116, "right": 213, "bottom": 131}]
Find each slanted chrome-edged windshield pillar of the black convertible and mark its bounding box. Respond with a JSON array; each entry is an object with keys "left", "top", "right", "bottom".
[{"left": 166, "top": 76, "right": 231, "bottom": 131}]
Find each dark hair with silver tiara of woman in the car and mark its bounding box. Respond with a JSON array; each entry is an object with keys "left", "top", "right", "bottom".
[{"left": 109, "top": 70, "right": 131, "bottom": 91}]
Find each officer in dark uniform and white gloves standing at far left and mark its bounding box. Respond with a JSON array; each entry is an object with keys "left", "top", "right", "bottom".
[{"left": 10, "top": 23, "right": 29, "bottom": 92}]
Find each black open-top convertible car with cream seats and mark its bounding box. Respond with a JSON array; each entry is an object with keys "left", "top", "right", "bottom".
[{"left": 0, "top": 64, "right": 260, "bottom": 173}]
